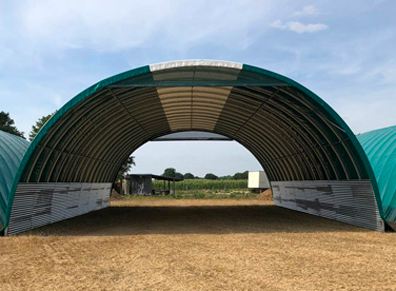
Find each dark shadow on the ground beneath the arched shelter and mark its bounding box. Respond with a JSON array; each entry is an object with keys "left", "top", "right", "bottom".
[{"left": 22, "top": 205, "right": 369, "bottom": 236}]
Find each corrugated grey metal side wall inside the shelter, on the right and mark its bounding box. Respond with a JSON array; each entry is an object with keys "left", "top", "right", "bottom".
[{"left": 271, "top": 180, "right": 384, "bottom": 231}]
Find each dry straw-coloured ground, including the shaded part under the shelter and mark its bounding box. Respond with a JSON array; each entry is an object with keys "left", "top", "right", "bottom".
[{"left": 0, "top": 199, "right": 396, "bottom": 291}]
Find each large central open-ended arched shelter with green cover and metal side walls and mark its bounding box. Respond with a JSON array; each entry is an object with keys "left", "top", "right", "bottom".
[{"left": 4, "top": 60, "right": 384, "bottom": 234}]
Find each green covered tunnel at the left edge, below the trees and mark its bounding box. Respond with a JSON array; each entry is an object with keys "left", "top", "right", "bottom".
[{"left": 0, "top": 130, "right": 29, "bottom": 229}]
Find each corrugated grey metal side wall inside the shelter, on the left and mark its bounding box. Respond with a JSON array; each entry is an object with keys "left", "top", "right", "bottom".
[{"left": 7, "top": 183, "right": 112, "bottom": 235}]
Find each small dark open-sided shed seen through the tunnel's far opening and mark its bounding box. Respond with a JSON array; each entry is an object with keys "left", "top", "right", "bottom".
[{"left": 122, "top": 174, "right": 183, "bottom": 196}]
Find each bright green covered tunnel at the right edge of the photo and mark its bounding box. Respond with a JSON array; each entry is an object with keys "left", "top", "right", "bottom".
[{"left": 357, "top": 126, "right": 396, "bottom": 229}]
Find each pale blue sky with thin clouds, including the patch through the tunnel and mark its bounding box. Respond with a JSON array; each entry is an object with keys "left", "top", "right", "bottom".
[{"left": 0, "top": 0, "right": 396, "bottom": 175}]
